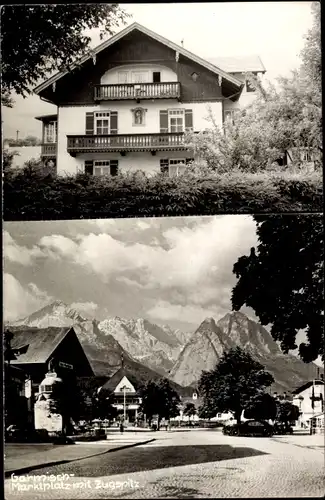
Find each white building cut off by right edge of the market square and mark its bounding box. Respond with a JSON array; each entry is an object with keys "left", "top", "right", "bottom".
[{"left": 292, "top": 378, "right": 324, "bottom": 431}]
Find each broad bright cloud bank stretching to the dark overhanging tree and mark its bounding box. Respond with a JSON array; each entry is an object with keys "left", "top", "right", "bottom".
[{"left": 33, "top": 215, "right": 256, "bottom": 296}]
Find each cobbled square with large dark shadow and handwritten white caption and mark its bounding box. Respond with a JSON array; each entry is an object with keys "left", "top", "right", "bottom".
[{"left": 5, "top": 430, "right": 325, "bottom": 500}]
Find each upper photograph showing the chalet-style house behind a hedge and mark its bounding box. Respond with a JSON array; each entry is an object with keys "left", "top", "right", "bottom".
[{"left": 1, "top": 2, "right": 323, "bottom": 220}]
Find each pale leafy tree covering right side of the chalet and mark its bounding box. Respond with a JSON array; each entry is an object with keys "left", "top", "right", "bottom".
[{"left": 187, "top": 2, "right": 322, "bottom": 173}]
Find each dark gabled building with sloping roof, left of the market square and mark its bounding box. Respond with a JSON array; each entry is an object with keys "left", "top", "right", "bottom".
[{"left": 9, "top": 326, "right": 94, "bottom": 428}]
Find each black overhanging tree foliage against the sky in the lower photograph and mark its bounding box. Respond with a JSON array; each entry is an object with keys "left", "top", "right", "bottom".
[{"left": 232, "top": 214, "right": 324, "bottom": 363}]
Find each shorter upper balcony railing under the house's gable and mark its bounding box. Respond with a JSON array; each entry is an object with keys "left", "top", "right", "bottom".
[{"left": 94, "top": 82, "right": 181, "bottom": 101}]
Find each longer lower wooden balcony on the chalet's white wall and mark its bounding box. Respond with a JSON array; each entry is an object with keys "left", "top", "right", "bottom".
[{"left": 67, "top": 132, "right": 188, "bottom": 156}]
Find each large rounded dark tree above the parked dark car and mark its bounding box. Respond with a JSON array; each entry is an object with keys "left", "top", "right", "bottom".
[{"left": 199, "top": 347, "right": 274, "bottom": 423}]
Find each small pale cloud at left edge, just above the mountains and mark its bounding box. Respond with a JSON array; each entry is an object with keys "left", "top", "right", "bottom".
[{"left": 3, "top": 273, "right": 53, "bottom": 321}]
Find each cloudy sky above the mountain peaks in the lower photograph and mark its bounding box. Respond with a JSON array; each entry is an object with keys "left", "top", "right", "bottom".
[{"left": 4, "top": 215, "right": 256, "bottom": 331}]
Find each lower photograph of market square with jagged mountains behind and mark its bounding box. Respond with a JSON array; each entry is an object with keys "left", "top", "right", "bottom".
[{"left": 4, "top": 214, "right": 324, "bottom": 499}]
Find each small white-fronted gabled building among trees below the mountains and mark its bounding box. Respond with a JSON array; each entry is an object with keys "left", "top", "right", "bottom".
[{"left": 99, "top": 366, "right": 141, "bottom": 424}]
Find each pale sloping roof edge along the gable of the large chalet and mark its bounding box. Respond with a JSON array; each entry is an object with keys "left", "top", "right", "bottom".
[{"left": 34, "top": 22, "right": 243, "bottom": 94}]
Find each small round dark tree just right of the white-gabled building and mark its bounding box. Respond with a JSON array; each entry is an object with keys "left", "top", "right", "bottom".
[{"left": 140, "top": 378, "right": 180, "bottom": 429}]
